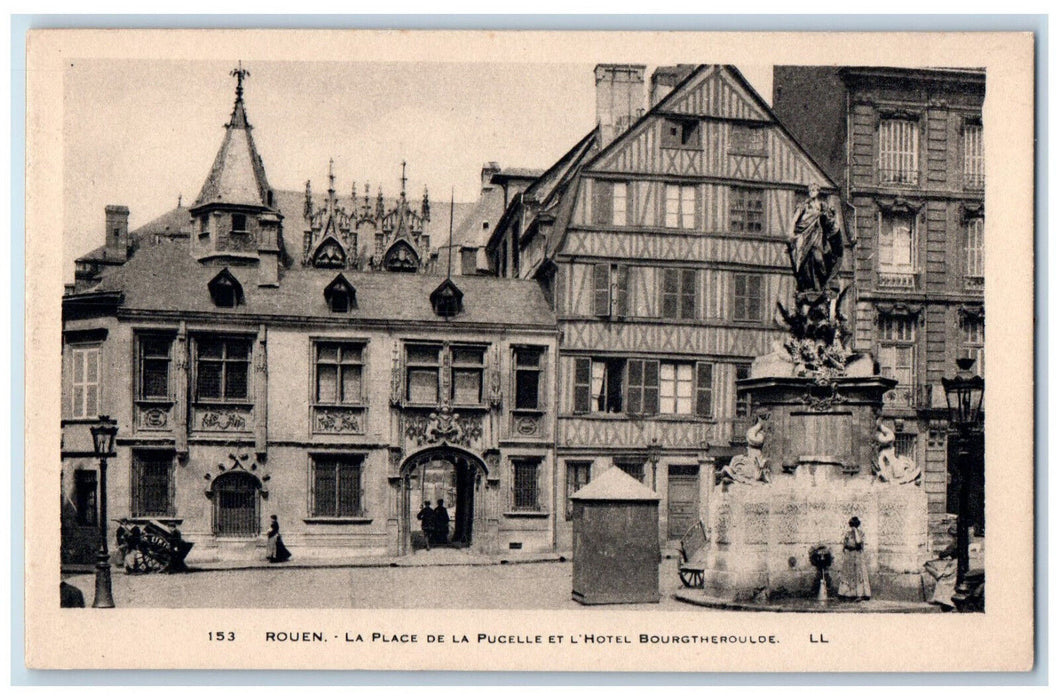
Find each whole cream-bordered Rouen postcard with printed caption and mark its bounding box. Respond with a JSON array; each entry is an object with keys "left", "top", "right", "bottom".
[{"left": 24, "top": 30, "right": 1035, "bottom": 671}]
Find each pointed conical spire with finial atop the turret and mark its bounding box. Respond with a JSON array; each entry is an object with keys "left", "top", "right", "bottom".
[{"left": 192, "top": 66, "right": 272, "bottom": 209}]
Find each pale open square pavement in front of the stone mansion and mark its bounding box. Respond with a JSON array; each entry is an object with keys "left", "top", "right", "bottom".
[{"left": 66, "top": 559, "right": 695, "bottom": 610}]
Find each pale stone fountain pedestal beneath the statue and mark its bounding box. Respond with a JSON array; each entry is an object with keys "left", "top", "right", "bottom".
[{"left": 704, "top": 376, "right": 929, "bottom": 600}]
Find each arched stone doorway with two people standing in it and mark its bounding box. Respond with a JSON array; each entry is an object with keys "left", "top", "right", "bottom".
[{"left": 398, "top": 446, "right": 496, "bottom": 554}]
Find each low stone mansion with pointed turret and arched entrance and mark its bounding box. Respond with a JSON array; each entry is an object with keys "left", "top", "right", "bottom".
[{"left": 61, "top": 71, "right": 558, "bottom": 562}]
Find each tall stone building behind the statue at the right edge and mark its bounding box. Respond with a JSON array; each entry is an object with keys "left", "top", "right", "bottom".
[{"left": 773, "top": 66, "right": 986, "bottom": 544}]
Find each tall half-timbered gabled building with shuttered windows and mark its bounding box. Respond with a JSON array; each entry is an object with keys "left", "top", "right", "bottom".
[{"left": 488, "top": 65, "right": 836, "bottom": 546}]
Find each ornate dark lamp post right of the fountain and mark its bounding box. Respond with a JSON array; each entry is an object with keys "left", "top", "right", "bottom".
[{"left": 941, "top": 358, "right": 985, "bottom": 594}]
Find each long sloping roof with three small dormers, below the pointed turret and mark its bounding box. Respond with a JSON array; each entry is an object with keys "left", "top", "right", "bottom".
[{"left": 88, "top": 240, "right": 556, "bottom": 329}]
